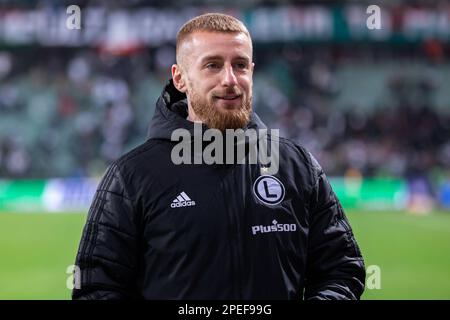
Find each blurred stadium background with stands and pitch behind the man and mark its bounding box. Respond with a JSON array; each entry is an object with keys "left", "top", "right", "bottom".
[{"left": 0, "top": 0, "right": 450, "bottom": 299}]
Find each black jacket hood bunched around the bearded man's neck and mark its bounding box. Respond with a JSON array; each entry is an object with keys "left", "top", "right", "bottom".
[{"left": 148, "top": 79, "right": 267, "bottom": 140}]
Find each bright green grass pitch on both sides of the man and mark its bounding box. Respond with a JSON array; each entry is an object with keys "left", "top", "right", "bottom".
[{"left": 0, "top": 211, "right": 450, "bottom": 299}]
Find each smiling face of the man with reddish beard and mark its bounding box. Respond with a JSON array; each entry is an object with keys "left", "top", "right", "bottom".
[{"left": 174, "top": 32, "right": 253, "bottom": 131}]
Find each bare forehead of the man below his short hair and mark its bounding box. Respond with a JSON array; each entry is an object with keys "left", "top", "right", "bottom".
[{"left": 181, "top": 31, "right": 252, "bottom": 59}]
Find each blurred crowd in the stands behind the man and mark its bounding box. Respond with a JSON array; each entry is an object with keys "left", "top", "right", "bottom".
[{"left": 0, "top": 45, "right": 450, "bottom": 184}]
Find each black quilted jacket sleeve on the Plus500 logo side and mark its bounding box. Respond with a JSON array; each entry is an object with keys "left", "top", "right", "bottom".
[{"left": 304, "top": 156, "right": 366, "bottom": 300}]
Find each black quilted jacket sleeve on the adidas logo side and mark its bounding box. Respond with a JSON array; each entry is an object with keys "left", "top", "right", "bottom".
[{"left": 72, "top": 164, "right": 138, "bottom": 300}]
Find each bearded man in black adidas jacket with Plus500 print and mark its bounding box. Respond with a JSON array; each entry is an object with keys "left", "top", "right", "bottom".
[{"left": 73, "top": 14, "right": 365, "bottom": 299}]
